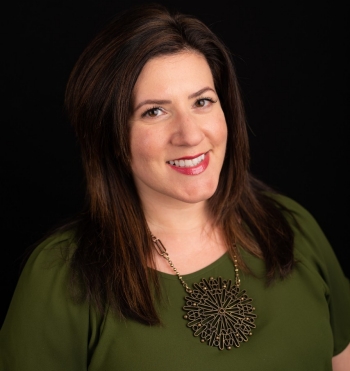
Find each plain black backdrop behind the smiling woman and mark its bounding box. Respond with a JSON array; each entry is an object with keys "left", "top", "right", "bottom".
[{"left": 0, "top": 0, "right": 350, "bottom": 324}]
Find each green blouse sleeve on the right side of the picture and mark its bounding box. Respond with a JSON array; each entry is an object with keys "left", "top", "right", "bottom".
[{"left": 278, "top": 193, "right": 350, "bottom": 356}]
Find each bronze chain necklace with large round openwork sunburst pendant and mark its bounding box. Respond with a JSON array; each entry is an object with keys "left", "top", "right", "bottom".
[{"left": 151, "top": 234, "right": 256, "bottom": 350}]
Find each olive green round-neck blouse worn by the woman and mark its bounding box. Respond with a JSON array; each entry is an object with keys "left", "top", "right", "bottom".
[{"left": 0, "top": 196, "right": 350, "bottom": 371}]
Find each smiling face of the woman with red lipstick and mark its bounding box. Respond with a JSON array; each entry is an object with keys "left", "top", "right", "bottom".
[{"left": 130, "top": 52, "right": 227, "bottom": 208}]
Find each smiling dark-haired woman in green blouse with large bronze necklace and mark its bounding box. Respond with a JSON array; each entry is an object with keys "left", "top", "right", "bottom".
[{"left": 0, "top": 5, "right": 350, "bottom": 371}]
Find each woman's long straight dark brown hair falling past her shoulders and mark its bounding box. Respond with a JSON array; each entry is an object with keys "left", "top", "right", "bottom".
[{"left": 66, "top": 4, "right": 294, "bottom": 324}]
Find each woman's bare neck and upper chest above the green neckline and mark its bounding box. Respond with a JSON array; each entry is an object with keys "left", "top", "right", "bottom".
[{"left": 143, "top": 193, "right": 226, "bottom": 274}]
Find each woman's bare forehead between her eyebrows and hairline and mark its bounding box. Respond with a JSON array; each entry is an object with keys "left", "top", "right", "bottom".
[{"left": 134, "top": 51, "right": 214, "bottom": 96}]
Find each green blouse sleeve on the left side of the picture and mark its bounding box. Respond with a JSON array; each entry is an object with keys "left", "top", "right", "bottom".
[{"left": 0, "top": 235, "right": 89, "bottom": 371}]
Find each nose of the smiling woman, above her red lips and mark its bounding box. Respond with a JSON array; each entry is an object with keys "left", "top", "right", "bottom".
[{"left": 171, "top": 113, "right": 205, "bottom": 146}]
